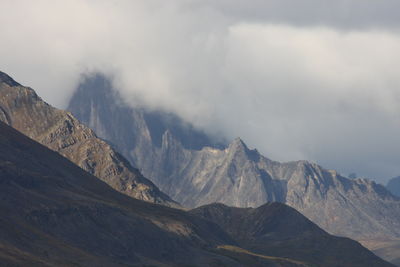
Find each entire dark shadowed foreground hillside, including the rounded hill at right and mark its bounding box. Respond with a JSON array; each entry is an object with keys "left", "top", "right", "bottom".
[{"left": 0, "top": 122, "right": 391, "bottom": 267}]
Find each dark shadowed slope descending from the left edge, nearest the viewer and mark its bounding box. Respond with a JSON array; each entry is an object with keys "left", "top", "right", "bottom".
[{"left": 0, "top": 122, "right": 234, "bottom": 266}]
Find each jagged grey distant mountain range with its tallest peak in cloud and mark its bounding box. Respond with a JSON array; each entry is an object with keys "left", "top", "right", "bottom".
[{"left": 69, "top": 72, "right": 400, "bottom": 264}]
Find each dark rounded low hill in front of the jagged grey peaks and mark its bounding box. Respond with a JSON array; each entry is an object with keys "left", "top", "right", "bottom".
[{"left": 190, "top": 202, "right": 390, "bottom": 266}]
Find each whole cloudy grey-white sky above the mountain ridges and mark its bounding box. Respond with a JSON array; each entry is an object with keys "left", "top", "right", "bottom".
[{"left": 0, "top": 0, "right": 400, "bottom": 182}]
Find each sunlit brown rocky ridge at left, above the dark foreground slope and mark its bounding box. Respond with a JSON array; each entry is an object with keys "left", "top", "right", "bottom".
[{"left": 0, "top": 72, "right": 177, "bottom": 205}]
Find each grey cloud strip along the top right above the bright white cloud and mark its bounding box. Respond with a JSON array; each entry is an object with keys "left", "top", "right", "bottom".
[{"left": 186, "top": 0, "right": 400, "bottom": 30}]
